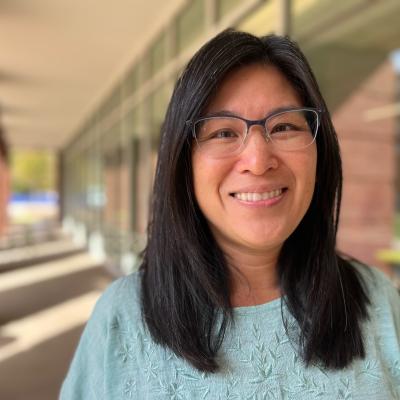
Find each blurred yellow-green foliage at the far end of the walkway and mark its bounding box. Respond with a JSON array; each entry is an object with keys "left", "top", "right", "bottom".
[{"left": 11, "top": 150, "right": 56, "bottom": 193}]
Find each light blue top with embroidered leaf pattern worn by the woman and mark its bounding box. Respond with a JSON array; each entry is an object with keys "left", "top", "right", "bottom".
[{"left": 60, "top": 270, "right": 400, "bottom": 400}]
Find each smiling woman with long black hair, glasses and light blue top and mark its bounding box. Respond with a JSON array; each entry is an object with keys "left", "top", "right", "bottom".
[{"left": 61, "top": 30, "right": 400, "bottom": 400}]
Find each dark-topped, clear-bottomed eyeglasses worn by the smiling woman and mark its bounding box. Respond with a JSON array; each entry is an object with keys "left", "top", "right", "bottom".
[{"left": 187, "top": 108, "right": 321, "bottom": 158}]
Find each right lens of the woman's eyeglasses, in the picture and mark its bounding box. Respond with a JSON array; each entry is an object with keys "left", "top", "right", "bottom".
[{"left": 265, "top": 110, "right": 318, "bottom": 151}]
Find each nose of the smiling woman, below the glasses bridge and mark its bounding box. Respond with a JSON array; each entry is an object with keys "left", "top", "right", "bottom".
[{"left": 237, "top": 125, "right": 279, "bottom": 175}]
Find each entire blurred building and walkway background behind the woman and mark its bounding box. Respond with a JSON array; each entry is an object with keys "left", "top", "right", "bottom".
[{"left": 0, "top": 0, "right": 400, "bottom": 400}]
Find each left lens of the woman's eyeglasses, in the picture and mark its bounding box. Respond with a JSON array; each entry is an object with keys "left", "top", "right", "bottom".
[{"left": 194, "top": 117, "right": 247, "bottom": 157}]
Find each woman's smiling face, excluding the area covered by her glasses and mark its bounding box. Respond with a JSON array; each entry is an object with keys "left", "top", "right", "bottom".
[{"left": 192, "top": 64, "right": 317, "bottom": 253}]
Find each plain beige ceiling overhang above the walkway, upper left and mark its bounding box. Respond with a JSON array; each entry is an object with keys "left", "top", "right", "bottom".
[{"left": 0, "top": 0, "right": 184, "bottom": 150}]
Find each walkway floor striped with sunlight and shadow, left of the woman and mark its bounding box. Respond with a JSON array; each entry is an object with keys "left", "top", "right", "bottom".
[{"left": 0, "top": 241, "right": 112, "bottom": 400}]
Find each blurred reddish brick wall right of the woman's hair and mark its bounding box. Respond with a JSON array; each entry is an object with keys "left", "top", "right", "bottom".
[{"left": 333, "top": 60, "right": 396, "bottom": 273}]
